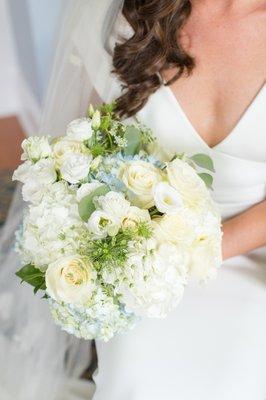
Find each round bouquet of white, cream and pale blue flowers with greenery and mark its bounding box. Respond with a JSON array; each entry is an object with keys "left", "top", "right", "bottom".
[{"left": 13, "top": 104, "right": 221, "bottom": 341}]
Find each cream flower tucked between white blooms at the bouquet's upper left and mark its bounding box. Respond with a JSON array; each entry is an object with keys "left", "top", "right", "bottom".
[{"left": 52, "top": 137, "right": 90, "bottom": 167}]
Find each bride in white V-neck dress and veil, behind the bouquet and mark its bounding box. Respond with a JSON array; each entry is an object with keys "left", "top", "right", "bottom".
[{"left": 0, "top": 0, "right": 266, "bottom": 400}]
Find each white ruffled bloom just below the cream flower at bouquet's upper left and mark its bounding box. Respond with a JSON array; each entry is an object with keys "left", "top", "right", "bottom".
[{"left": 60, "top": 153, "right": 92, "bottom": 184}]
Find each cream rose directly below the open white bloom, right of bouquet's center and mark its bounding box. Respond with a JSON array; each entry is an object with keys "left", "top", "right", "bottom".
[{"left": 152, "top": 212, "right": 195, "bottom": 246}]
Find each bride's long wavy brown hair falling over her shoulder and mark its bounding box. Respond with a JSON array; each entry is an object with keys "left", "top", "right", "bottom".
[{"left": 113, "top": 0, "right": 194, "bottom": 116}]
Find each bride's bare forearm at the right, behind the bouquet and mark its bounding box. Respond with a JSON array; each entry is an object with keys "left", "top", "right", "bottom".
[{"left": 222, "top": 201, "right": 266, "bottom": 260}]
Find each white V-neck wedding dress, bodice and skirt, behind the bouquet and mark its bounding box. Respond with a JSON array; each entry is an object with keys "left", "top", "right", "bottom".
[{"left": 90, "top": 82, "right": 266, "bottom": 400}]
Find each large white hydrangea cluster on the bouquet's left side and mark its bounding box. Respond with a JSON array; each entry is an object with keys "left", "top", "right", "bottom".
[{"left": 16, "top": 182, "right": 84, "bottom": 270}]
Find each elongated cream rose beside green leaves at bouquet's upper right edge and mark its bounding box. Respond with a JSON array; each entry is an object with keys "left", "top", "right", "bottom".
[{"left": 166, "top": 159, "right": 210, "bottom": 213}]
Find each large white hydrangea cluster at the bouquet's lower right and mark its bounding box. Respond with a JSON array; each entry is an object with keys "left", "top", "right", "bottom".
[{"left": 118, "top": 243, "right": 187, "bottom": 318}]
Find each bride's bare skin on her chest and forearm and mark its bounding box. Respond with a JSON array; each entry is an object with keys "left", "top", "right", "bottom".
[{"left": 165, "top": 0, "right": 266, "bottom": 259}]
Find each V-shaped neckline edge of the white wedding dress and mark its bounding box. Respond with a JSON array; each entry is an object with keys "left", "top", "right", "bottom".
[{"left": 162, "top": 83, "right": 266, "bottom": 150}]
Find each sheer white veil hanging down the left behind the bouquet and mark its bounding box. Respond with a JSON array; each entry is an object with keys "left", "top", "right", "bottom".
[{"left": 0, "top": 0, "right": 123, "bottom": 400}]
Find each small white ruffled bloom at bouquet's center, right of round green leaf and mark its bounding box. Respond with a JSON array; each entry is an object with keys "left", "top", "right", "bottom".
[{"left": 97, "top": 191, "right": 130, "bottom": 220}]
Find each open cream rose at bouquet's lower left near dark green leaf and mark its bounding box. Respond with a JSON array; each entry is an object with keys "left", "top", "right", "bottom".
[{"left": 45, "top": 256, "right": 96, "bottom": 304}]
